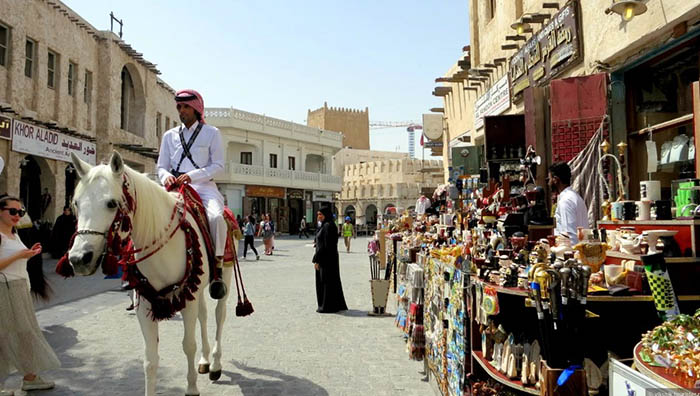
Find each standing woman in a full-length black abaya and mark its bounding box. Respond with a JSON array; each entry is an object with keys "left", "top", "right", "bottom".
[{"left": 312, "top": 206, "right": 348, "bottom": 313}]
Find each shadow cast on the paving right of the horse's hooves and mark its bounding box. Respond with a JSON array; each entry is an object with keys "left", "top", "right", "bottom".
[{"left": 216, "top": 360, "right": 328, "bottom": 396}]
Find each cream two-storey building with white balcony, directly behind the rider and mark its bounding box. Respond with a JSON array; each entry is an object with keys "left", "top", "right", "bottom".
[{"left": 205, "top": 108, "right": 343, "bottom": 233}]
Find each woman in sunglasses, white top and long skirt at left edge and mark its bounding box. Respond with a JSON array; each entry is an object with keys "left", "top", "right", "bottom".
[{"left": 0, "top": 196, "right": 61, "bottom": 396}]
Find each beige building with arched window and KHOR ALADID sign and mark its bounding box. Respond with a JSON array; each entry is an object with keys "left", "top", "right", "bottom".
[{"left": 0, "top": 0, "right": 178, "bottom": 221}]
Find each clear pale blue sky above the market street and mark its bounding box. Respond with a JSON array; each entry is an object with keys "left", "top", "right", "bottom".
[{"left": 64, "top": 0, "right": 469, "bottom": 157}]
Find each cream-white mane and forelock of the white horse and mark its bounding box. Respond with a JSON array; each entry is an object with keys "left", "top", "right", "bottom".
[{"left": 75, "top": 165, "right": 177, "bottom": 247}]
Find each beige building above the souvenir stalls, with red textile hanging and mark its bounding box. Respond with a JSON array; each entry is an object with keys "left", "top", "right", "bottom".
[{"left": 433, "top": 0, "right": 700, "bottom": 199}]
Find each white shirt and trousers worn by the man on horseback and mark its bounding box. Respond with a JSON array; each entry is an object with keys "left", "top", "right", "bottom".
[{"left": 158, "top": 121, "right": 226, "bottom": 256}]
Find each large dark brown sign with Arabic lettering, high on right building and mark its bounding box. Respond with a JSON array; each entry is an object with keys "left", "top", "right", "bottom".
[{"left": 508, "top": 1, "right": 583, "bottom": 98}]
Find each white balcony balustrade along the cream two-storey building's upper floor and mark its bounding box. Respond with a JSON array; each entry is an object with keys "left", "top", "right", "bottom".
[{"left": 222, "top": 162, "right": 342, "bottom": 189}]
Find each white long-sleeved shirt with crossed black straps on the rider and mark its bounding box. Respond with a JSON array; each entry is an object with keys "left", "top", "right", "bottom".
[{"left": 158, "top": 121, "right": 224, "bottom": 192}]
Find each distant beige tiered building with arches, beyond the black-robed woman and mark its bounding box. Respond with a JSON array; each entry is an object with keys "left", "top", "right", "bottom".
[{"left": 336, "top": 158, "right": 443, "bottom": 229}]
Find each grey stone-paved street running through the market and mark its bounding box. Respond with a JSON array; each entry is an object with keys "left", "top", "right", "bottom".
[{"left": 6, "top": 237, "right": 433, "bottom": 396}]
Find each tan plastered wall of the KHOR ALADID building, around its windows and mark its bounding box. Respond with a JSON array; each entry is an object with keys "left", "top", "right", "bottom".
[{"left": 0, "top": 0, "right": 178, "bottom": 220}]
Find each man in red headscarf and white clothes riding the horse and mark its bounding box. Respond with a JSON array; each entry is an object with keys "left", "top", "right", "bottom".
[{"left": 157, "top": 89, "right": 227, "bottom": 298}]
